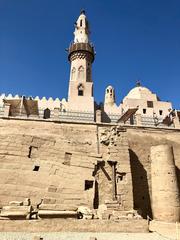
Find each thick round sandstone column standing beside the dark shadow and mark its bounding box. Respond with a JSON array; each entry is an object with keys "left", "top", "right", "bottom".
[{"left": 151, "top": 145, "right": 180, "bottom": 222}]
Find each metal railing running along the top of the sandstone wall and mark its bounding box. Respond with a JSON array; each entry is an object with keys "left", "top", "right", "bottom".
[{"left": 0, "top": 106, "right": 174, "bottom": 128}]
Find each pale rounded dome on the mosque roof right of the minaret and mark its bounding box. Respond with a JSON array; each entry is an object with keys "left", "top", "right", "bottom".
[{"left": 125, "top": 86, "right": 157, "bottom": 100}]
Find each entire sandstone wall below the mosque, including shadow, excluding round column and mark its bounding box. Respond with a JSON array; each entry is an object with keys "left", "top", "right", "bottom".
[{"left": 0, "top": 119, "right": 180, "bottom": 217}]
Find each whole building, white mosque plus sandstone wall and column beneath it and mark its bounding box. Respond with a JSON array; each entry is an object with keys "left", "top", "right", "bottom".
[{"left": 0, "top": 11, "right": 180, "bottom": 235}]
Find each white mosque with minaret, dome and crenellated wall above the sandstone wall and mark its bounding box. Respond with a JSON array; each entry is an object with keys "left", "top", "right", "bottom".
[{"left": 0, "top": 11, "right": 180, "bottom": 126}]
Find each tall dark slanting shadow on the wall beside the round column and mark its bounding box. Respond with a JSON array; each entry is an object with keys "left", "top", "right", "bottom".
[{"left": 129, "top": 149, "right": 152, "bottom": 218}]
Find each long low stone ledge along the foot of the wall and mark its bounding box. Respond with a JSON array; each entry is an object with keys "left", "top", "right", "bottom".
[{"left": 0, "top": 219, "right": 149, "bottom": 232}]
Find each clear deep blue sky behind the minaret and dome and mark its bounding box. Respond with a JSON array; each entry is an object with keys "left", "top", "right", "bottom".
[{"left": 0, "top": 0, "right": 180, "bottom": 108}]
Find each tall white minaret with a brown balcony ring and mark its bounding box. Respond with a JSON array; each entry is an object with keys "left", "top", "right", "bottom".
[{"left": 68, "top": 11, "right": 95, "bottom": 112}]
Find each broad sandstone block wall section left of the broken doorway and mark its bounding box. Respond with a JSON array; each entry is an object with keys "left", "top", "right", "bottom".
[{"left": 0, "top": 120, "right": 97, "bottom": 210}]
